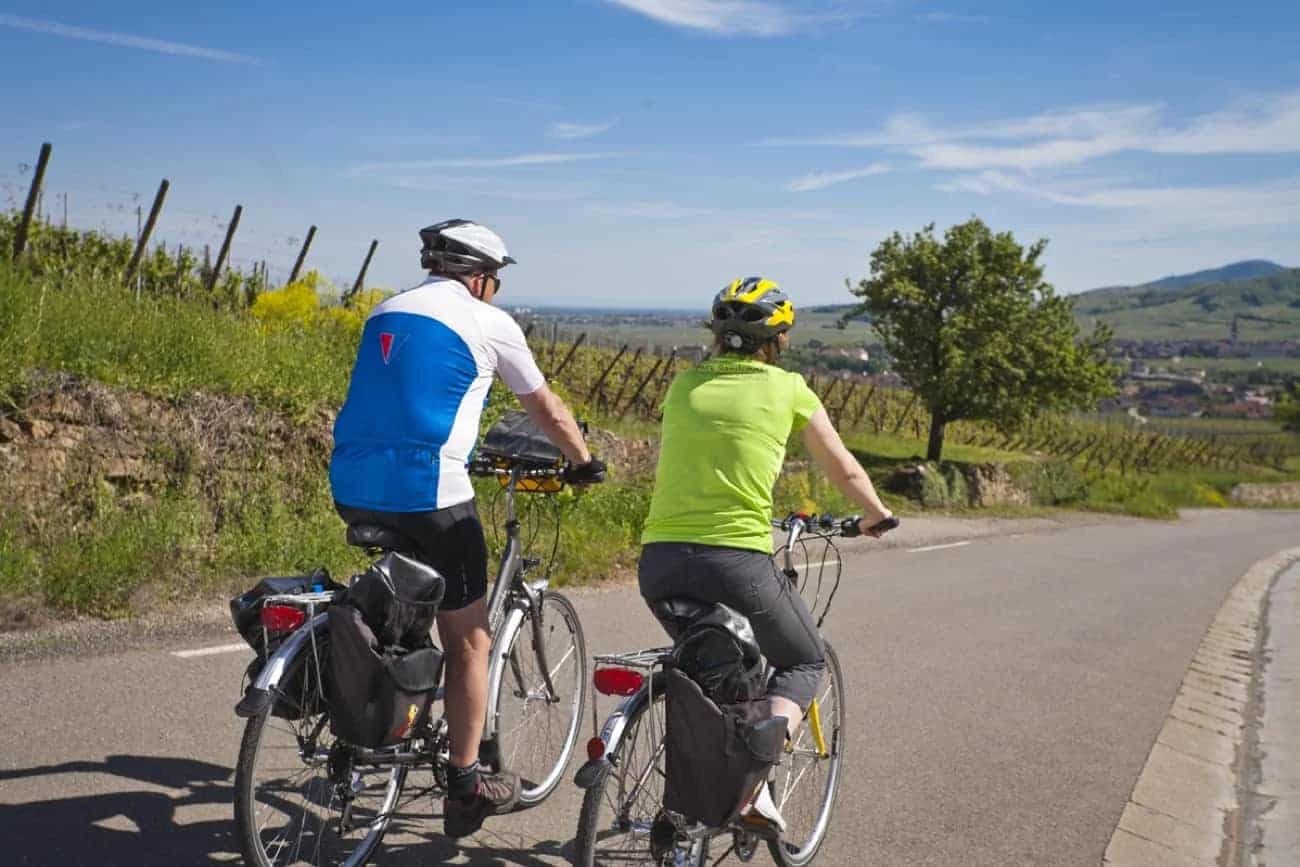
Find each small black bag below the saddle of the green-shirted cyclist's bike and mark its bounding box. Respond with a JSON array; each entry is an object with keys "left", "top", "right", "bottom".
[{"left": 672, "top": 603, "right": 767, "bottom": 705}]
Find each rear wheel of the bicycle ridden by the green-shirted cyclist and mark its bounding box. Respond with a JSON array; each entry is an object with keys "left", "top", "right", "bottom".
[{"left": 573, "top": 677, "right": 709, "bottom": 867}]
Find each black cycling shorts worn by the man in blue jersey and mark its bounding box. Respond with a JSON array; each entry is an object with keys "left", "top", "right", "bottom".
[{"left": 334, "top": 500, "right": 488, "bottom": 611}]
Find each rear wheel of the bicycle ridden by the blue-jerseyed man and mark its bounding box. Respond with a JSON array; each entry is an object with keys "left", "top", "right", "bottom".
[{"left": 235, "top": 638, "right": 407, "bottom": 867}]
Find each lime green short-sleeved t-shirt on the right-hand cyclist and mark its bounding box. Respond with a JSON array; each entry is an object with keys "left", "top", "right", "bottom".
[{"left": 641, "top": 356, "right": 822, "bottom": 554}]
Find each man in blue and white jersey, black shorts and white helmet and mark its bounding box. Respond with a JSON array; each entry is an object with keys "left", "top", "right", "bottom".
[{"left": 330, "top": 220, "right": 605, "bottom": 837}]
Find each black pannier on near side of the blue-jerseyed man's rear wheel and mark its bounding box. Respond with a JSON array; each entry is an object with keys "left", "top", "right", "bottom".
[{"left": 325, "top": 552, "right": 446, "bottom": 749}]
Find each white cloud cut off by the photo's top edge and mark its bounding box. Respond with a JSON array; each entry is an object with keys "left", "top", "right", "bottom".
[{"left": 605, "top": 0, "right": 859, "bottom": 36}]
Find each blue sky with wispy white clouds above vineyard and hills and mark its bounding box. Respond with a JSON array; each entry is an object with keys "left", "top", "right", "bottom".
[{"left": 0, "top": 0, "right": 1300, "bottom": 308}]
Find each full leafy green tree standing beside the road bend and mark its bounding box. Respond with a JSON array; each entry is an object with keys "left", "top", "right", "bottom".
[{"left": 845, "top": 218, "right": 1118, "bottom": 460}]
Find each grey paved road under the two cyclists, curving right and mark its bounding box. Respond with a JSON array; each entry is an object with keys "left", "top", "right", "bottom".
[{"left": 0, "top": 512, "right": 1300, "bottom": 867}]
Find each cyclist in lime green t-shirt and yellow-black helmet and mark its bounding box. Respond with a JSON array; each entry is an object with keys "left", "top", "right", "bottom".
[{"left": 638, "top": 277, "right": 891, "bottom": 824}]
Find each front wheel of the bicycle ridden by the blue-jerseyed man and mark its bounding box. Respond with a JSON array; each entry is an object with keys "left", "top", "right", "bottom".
[{"left": 495, "top": 591, "right": 588, "bottom": 806}]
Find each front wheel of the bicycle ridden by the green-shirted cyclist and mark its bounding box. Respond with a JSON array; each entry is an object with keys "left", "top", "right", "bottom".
[{"left": 767, "top": 642, "right": 845, "bottom": 867}]
